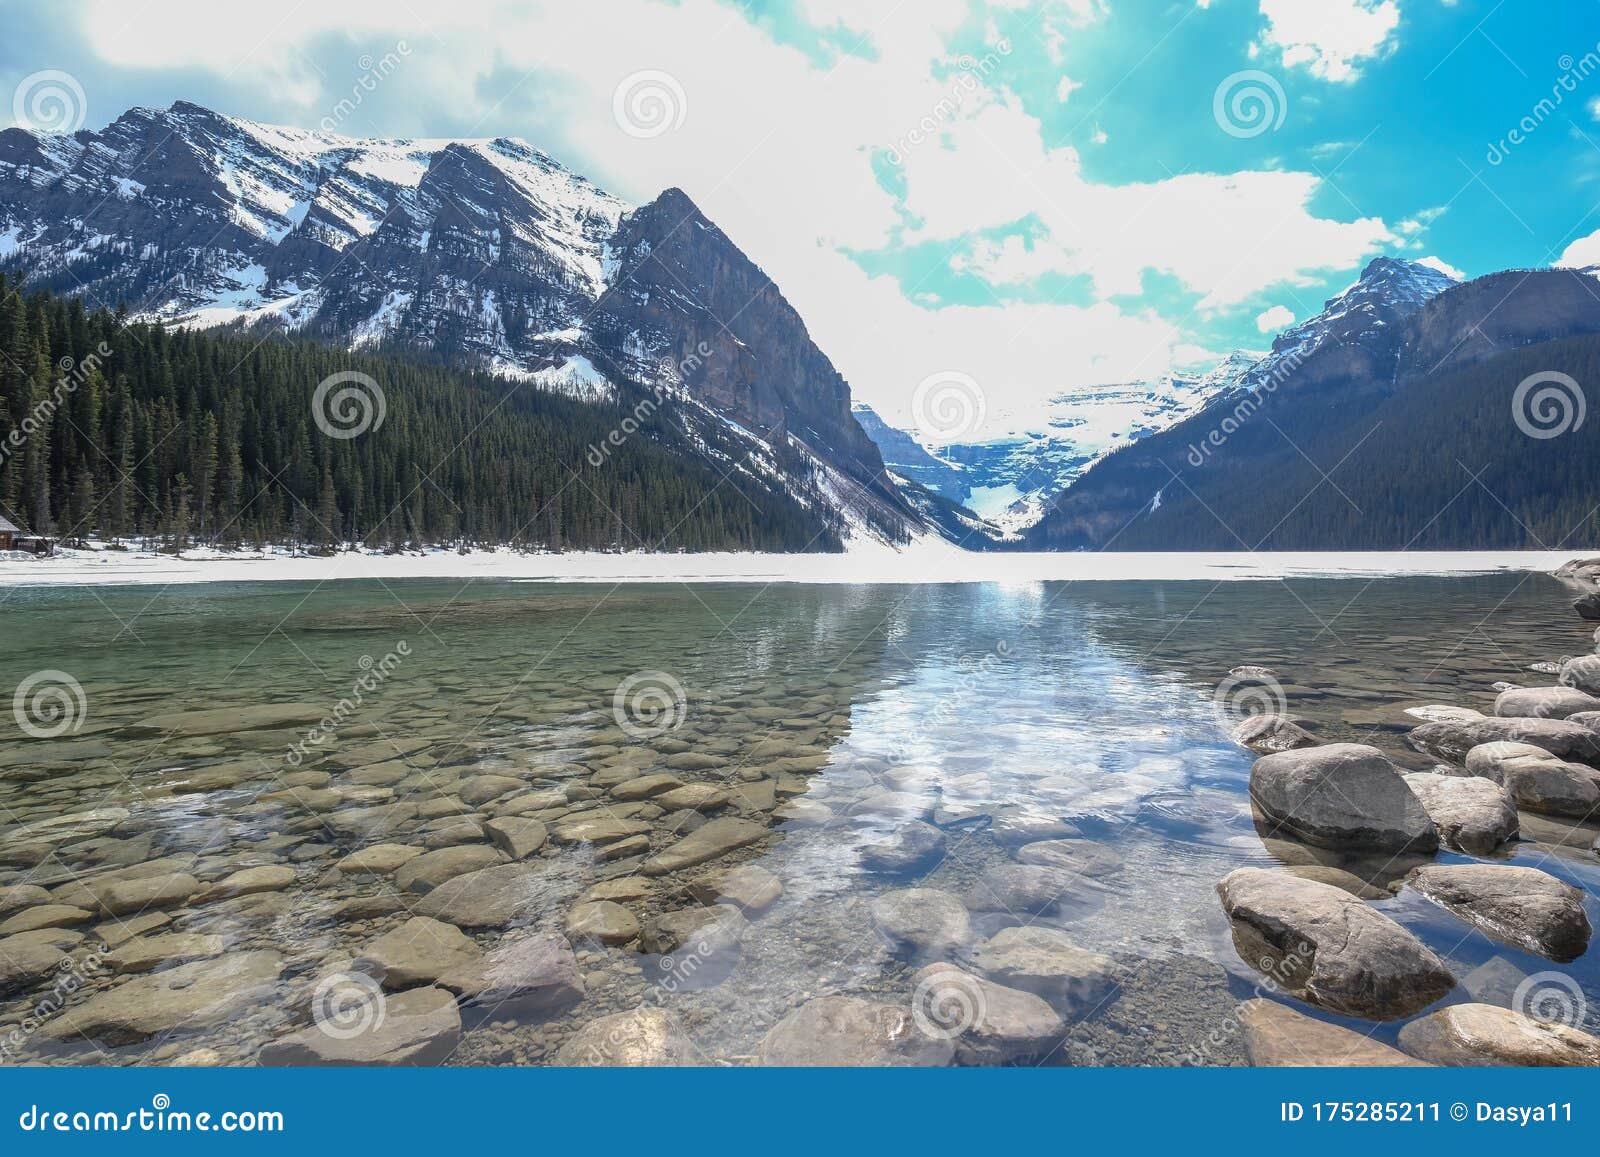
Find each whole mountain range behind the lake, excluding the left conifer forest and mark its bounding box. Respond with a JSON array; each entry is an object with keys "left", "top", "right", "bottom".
[{"left": 9, "top": 102, "right": 1600, "bottom": 549}]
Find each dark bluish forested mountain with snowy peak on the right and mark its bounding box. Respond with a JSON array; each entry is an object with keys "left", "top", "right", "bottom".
[{"left": 1026, "top": 258, "right": 1600, "bottom": 550}]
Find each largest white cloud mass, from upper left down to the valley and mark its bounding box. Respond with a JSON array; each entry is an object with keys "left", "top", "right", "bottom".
[{"left": 68, "top": 0, "right": 1392, "bottom": 432}]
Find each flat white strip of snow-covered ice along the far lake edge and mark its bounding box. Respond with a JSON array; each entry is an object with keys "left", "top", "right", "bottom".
[{"left": 0, "top": 541, "right": 1594, "bottom": 587}]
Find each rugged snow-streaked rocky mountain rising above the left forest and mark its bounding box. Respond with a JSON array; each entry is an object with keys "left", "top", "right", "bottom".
[{"left": 0, "top": 102, "right": 934, "bottom": 541}]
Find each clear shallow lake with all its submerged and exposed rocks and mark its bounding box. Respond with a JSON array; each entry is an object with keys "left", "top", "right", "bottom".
[{"left": 0, "top": 566, "right": 1600, "bottom": 1066}]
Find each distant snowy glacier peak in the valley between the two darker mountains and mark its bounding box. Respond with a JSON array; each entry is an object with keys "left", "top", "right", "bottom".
[{"left": 856, "top": 350, "right": 1262, "bottom": 531}]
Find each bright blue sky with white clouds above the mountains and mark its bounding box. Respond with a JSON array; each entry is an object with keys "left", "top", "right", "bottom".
[{"left": 0, "top": 0, "right": 1600, "bottom": 434}]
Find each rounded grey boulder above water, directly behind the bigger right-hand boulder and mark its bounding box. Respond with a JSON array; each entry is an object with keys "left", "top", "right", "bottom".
[{"left": 1250, "top": 743, "right": 1438, "bottom": 853}]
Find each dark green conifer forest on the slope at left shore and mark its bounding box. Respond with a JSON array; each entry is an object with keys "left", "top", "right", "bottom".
[{"left": 0, "top": 275, "right": 840, "bottom": 550}]
